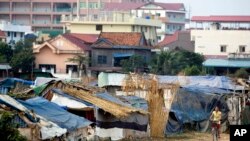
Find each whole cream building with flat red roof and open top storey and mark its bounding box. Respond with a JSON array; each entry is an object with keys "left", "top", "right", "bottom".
[{"left": 191, "top": 16, "right": 250, "bottom": 58}]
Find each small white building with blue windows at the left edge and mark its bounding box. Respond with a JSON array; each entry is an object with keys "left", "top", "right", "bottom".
[{"left": 0, "top": 21, "right": 32, "bottom": 44}]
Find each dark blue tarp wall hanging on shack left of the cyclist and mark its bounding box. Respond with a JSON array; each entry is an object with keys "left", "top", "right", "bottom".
[{"left": 166, "top": 86, "right": 230, "bottom": 134}]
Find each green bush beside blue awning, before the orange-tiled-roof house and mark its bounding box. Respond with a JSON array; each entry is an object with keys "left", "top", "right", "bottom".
[{"left": 121, "top": 55, "right": 147, "bottom": 72}]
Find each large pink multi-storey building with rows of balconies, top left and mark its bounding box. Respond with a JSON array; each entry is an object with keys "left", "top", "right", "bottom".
[{"left": 0, "top": 0, "right": 153, "bottom": 31}]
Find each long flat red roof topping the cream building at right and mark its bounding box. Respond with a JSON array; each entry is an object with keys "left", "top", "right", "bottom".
[{"left": 191, "top": 15, "right": 250, "bottom": 23}]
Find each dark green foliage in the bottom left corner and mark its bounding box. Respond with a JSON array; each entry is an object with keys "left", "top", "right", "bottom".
[{"left": 0, "top": 112, "right": 27, "bottom": 141}]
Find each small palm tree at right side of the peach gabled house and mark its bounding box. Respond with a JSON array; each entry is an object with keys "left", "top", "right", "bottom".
[{"left": 67, "top": 54, "right": 89, "bottom": 76}]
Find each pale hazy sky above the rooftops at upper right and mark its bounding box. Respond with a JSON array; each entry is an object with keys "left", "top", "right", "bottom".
[{"left": 155, "top": 0, "right": 250, "bottom": 16}]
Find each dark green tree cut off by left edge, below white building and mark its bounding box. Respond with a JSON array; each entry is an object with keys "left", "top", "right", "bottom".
[{"left": 0, "top": 42, "right": 13, "bottom": 63}]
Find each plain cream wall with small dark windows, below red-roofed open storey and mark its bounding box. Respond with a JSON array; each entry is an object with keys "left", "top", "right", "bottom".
[{"left": 191, "top": 30, "right": 250, "bottom": 56}]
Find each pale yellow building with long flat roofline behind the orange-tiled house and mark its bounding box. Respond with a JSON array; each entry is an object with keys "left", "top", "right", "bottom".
[{"left": 62, "top": 12, "right": 161, "bottom": 45}]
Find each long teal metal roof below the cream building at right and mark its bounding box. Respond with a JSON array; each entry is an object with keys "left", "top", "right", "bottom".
[{"left": 203, "top": 59, "right": 250, "bottom": 68}]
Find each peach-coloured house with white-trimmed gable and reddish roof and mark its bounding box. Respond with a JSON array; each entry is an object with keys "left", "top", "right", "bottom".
[{"left": 33, "top": 33, "right": 98, "bottom": 76}]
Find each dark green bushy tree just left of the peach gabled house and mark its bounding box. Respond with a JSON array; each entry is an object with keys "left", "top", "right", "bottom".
[{"left": 10, "top": 40, "right": 35, "bottom": 72}]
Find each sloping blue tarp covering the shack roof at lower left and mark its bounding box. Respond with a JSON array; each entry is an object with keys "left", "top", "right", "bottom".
[{"left": 19, "top": 97, "right": 92, "bottom": 131}]
